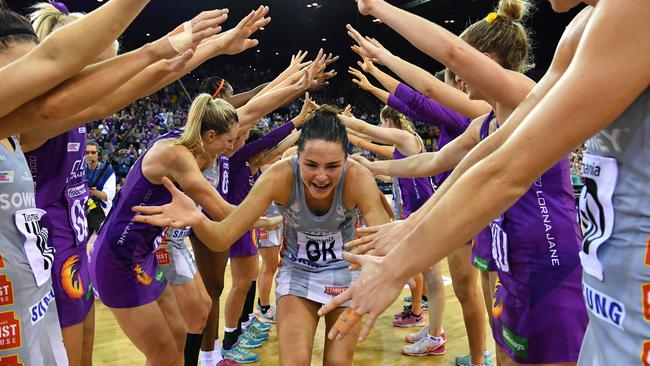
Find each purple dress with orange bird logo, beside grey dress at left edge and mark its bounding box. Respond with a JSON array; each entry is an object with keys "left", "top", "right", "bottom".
[{"left": 25, "top": 127, "right": 94, "bottom": 327}]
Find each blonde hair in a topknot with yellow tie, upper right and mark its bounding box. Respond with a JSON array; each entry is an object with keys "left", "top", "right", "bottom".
[{"left": 460, "top": 0, "right": 535, "bottom": 72}]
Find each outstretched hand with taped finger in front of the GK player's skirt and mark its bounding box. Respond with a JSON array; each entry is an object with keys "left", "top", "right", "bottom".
[{"left": 318, "top": 253, "right": 404, "bottom": 341}]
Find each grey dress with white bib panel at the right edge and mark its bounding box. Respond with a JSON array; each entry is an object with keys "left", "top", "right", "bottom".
[{"left": 579, "top": 89, "right": 650, "bottom": 366}]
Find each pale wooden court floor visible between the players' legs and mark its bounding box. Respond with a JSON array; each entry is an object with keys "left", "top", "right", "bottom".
[{"left": 93, "top": 263, "right": 494, "bottom": 366}]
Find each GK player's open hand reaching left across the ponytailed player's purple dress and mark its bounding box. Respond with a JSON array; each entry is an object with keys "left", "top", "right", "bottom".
[{"left": 131, "top": 177, "right": 204, "bottom": 228}]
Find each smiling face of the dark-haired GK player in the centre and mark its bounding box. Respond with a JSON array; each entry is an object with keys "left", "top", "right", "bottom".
[{"left": 298, "top": 139, "right": 345, "bottom": 200}]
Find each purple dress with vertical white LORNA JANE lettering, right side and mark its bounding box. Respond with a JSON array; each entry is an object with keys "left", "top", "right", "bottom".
[{"left": 492, "top": 138, "right": 587, "bottom": 363}]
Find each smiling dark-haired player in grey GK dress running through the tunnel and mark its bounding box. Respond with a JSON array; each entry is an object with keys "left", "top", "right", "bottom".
[{"left": 134, "top": 108, "right": 388, "bottom": 364}]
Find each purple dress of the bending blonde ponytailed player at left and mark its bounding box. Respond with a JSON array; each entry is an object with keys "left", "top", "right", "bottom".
[{"left": 89, "top": 131, "right": 179, "bottom": 308}]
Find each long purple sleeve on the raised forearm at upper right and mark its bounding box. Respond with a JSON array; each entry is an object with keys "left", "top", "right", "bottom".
[{"left": 388, "top": 83, "right": 471, "bottom": 133}]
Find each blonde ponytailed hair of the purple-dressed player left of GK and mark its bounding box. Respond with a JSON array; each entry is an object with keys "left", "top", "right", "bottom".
[{"left": 176, "top": 93, "right": 239, "bottom": 159}]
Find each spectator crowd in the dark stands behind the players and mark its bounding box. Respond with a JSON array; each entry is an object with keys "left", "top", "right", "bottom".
[{"left": 87, "top": 65, "right": 439, "bottom": 186}]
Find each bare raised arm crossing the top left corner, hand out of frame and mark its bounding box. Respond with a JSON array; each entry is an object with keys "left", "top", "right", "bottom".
[{"left": 0, "top": 0, "right": 149, "bottom": 116}]
